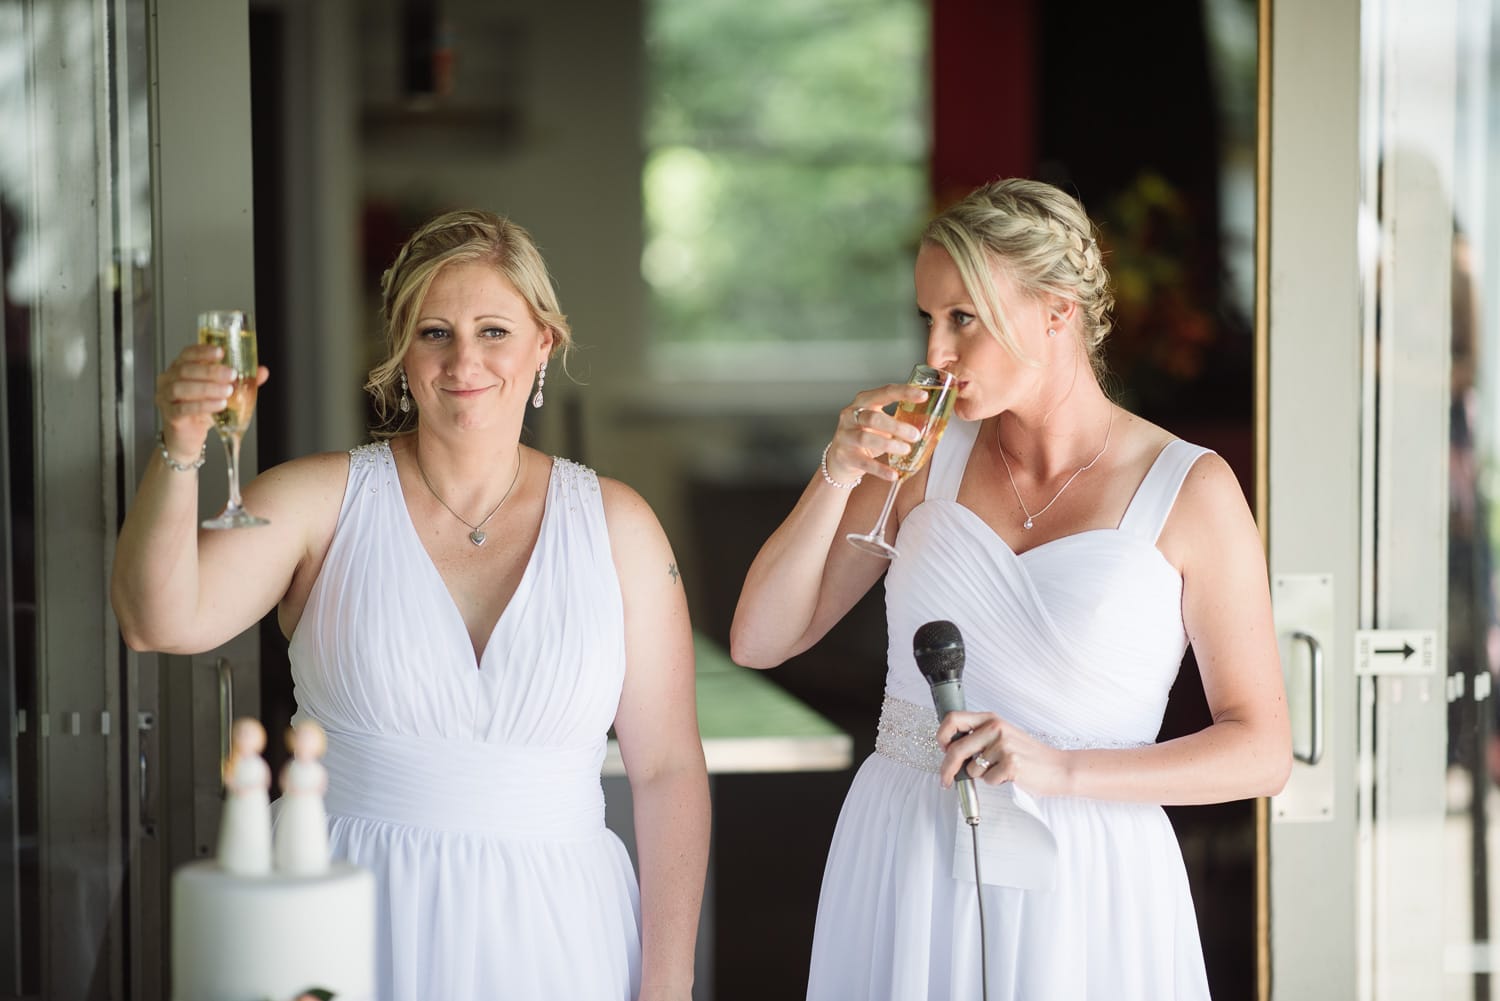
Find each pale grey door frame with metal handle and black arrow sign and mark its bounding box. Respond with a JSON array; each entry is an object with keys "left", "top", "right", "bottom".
[{"left": 1260, "top": 0, "right": 1460, "bottom": 1001}]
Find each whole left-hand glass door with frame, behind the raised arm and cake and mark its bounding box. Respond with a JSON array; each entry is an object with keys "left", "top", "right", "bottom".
[{"left": 0, "top": 0, "right": 257, "bottom": 1001}]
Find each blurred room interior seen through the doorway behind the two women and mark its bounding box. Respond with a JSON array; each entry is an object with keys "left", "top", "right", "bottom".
[{"left": 251, "top": 0, "right": 1257, "bottom": 1001}]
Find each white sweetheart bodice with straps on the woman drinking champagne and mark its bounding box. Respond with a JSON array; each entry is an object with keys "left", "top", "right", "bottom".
[{"left": 885, "top": 422, "right": 1205, "bottom": 746}]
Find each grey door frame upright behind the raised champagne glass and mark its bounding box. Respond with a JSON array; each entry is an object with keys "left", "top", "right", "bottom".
[{"left": 132, "top": 0, "right": 260, "bottom": 998}]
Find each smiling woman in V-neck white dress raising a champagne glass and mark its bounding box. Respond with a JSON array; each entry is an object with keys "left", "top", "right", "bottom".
[{"left": 113, "top": 212, "right": 708, "bottom": 1001}]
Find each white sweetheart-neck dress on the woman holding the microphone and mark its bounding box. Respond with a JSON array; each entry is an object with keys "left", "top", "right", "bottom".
[{"left": 807, "top": 420, "right": 1209, "bottom": 1001}]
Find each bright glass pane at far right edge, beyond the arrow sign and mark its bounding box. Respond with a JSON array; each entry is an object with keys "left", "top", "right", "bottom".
[{"left": 1428, "top": 0, "right": 1500, "bottom": 1001}]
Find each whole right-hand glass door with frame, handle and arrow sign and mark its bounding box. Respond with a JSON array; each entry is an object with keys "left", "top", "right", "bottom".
[{"left": 1263, "top": 0, "right": 1500, "bottom": 1001}]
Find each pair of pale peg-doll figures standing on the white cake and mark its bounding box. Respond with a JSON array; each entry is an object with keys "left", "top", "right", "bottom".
[{"left": 218, "top": 717, "right": 329, "bottom": 876}]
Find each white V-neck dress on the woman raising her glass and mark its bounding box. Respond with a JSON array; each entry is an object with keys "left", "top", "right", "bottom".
[{"left": 285, "top": 443, "right": 641, "bottom": 1001}]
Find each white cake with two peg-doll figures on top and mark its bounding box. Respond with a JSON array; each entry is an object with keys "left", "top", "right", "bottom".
[{"left": 171, "top": 720, "right": 375, "bottom": 1001}]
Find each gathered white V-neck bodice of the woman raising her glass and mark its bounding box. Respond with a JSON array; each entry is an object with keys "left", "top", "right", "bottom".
[{"left": 291, "top": 444, "right": 626, "bottom": 747}]
